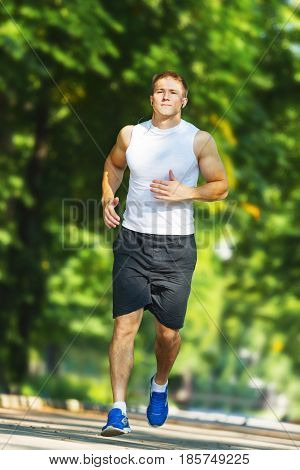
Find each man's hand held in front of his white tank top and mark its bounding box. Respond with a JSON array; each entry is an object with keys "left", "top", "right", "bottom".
[{"left": 150, "top": 170, "right": 194, "bottom": 202}]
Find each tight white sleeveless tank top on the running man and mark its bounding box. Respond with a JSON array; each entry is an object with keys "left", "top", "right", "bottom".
[{"left": 122, "top": 119, "right": 199, "bottom": 235}]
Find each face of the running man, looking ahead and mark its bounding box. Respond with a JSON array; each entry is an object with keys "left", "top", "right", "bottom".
[{"left": 150, "top": 77, "right": 187, "bottom": 116}]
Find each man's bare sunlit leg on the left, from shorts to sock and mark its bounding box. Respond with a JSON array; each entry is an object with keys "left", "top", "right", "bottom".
[{"left": 109, "top": 307, "right": 144, "bottom": 402}]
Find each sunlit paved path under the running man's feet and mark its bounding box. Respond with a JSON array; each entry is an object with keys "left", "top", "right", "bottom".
[{"left": 0, "top": 408, "right": 300, "bottom": 450}]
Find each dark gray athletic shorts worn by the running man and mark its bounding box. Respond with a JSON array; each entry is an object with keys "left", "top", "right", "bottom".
[{"left": 113, "top": 226, "right": 197, "bottom": 329}]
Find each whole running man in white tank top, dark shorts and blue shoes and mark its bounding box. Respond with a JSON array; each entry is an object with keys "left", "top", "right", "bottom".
[{"left": 101, "top": 71, "right": 228, "bottom": 436}]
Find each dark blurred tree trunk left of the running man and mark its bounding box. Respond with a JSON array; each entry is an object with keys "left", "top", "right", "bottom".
[{"left": 9, "top": 92, "right": 48, "bottom": 386}]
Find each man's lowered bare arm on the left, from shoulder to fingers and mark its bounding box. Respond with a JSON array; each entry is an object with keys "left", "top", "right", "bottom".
[{"left": 101, "top": 126, "right": 133, "bottom": 228}]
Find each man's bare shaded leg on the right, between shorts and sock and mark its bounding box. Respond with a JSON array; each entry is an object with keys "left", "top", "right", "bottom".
[{"left": 155, "top": 319, "right": 181, "bottom": 385}]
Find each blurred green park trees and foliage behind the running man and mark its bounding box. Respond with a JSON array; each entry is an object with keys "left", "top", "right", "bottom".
[{"left": 0, "top": 0, "right": 300, "bottom": 422}]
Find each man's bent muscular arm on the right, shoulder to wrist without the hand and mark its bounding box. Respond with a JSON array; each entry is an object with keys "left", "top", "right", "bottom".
[{"left": 192, "top": 131, "right": 229, "bottom": 202}]
